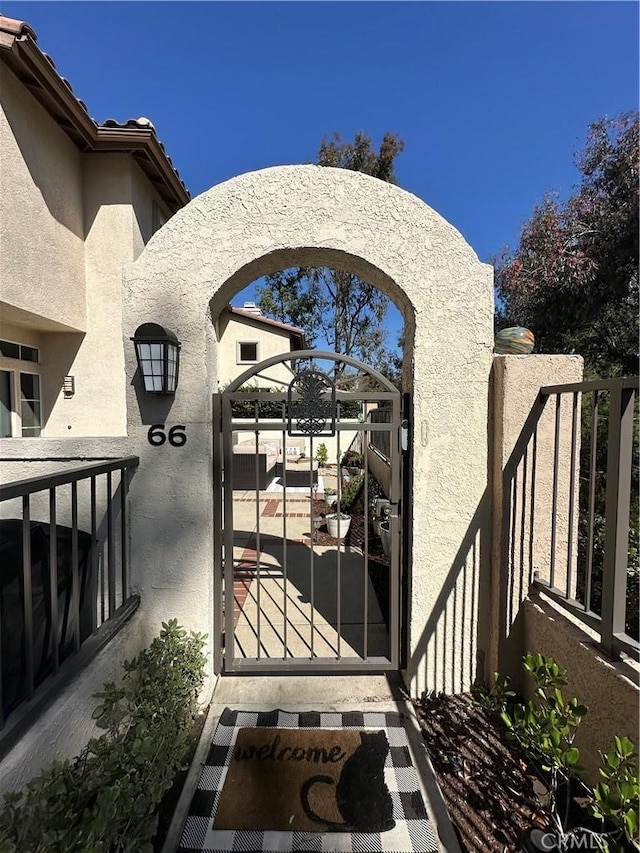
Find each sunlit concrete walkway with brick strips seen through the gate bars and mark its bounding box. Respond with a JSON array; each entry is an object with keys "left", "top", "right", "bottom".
[{"left": 233, "top": 491, "right": 390, "bottom": 660}]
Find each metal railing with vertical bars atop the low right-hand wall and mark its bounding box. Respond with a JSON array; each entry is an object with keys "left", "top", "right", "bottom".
[{"left": 528, "top": 377, "right": 640, "bottom": 660}]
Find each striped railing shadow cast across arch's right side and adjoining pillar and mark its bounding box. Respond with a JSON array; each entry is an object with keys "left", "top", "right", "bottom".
[{"left": 408, "top": 380, "right": 553, "bottom": 694}]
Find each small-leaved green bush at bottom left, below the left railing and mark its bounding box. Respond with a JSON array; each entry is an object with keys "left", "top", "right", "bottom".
[{"left": 0, "top": 619, "right": 206, "bottom": 853}]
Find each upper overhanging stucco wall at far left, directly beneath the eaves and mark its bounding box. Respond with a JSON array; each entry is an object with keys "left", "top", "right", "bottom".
[{"left": 0, "top": 64, "right": 86, "bottom": 330}]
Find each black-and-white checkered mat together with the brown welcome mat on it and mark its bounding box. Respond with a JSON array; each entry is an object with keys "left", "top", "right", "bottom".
[{"left": 179, "top": 708, "right": 438, "bottom": 853}]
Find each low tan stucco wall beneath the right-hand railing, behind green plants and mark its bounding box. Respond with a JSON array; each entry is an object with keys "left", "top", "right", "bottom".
[{"left": 516, "top": 595, "right": 640, "bottom": 784}]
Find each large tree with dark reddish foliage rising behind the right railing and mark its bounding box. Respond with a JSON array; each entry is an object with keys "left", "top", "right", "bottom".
[{"left": 494, "top": 112, "right": 639, "bottom": 376}]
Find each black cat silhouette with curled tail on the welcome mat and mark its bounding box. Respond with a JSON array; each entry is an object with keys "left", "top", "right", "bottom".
[{"left": 300, "top": 731, "right": 396, "bottom": 832}]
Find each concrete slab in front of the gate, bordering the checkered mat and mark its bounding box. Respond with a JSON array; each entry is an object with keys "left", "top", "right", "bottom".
[{"left": 162, "top": 675, "right": 461, "bottom": 853}]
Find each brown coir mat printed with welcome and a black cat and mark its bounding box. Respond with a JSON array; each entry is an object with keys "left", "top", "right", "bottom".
[{"left": 213, "top": 728, "right": 395, "bottom": 832}]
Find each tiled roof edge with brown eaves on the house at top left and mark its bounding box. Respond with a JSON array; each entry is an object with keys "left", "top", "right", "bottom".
[{"left": 0, "top": 15, "right": 190, "bottom": 213}]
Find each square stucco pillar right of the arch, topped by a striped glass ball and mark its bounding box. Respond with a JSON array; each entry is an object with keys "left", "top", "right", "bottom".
[{"left": 487, "top": 355, "right": 583, "bottom": 676}]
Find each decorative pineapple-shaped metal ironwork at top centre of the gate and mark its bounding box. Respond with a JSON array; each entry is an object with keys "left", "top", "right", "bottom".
[{"left": 287, "top": 368, "right": 336, "bottom": 436}]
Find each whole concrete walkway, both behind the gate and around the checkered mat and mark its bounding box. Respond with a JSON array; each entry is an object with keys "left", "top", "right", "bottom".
[{"left": 162, "top": 482, "right": 460, "bottom": 853}]
